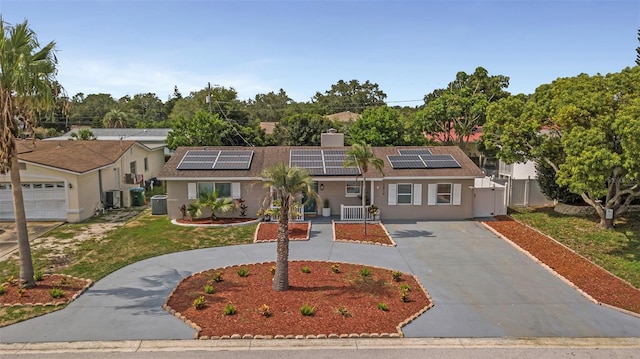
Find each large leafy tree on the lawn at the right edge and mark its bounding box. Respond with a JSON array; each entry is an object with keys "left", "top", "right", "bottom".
[{"left": 483, "top": 66, "right": 640, "bottom": 228}]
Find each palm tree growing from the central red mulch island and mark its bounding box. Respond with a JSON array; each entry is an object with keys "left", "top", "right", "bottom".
[{"left": 262, "top": 163, "right": 318, "bottom": 291}]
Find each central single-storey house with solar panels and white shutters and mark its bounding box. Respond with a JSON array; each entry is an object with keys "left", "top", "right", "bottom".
[{"left": 158, "top": 133, "right": 484, "bottom": 220}]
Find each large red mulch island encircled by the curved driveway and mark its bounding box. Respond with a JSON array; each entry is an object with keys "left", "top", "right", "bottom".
[{"left": 167, "top": 261, "right": 431, "bottom": 337}]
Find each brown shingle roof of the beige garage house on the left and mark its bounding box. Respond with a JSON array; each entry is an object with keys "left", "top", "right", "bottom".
[{"left": 16, "top": 140, "right": 142, "bottom": 173}]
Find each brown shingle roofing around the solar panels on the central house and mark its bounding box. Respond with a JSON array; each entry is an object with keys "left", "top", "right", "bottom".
[{"left": 158, "top": 146, "right": 483, "bottom": 179}]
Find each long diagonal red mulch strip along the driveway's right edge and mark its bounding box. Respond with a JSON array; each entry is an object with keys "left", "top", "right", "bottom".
[{"left": 485, "top": 216, "right": 640, "bottom": 313}]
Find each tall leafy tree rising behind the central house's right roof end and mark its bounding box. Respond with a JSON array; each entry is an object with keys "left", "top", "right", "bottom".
[{"left": 414, "top": 67, "right": 509, "bottom": 153}]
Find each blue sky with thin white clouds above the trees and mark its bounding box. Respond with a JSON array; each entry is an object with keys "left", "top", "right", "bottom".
[{"left": 0, "top": 0, "right": 640, "bottom": 106}]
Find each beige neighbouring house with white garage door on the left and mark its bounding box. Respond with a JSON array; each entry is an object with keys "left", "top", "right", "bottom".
[{"left": 0, "top": 140, "right": 164, "bottom": 222}]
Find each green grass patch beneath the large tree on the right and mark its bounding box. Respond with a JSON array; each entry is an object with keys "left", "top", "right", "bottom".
[{"left": 510, "top": 208, "right": 640, "bottom": 288}]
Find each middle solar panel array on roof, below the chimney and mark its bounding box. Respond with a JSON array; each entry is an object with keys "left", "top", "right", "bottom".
[{"left": 289, "top": 149, "right": 360, "bottom": 176}]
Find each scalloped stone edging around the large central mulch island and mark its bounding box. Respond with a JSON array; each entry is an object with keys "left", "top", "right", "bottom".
[{"left": 162, "top": 260, "right": 434, "bottom": 340}]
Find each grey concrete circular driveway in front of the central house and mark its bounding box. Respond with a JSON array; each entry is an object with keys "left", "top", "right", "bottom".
[{"left": 0, "top": 219, "right": 640, "bottom": 343}]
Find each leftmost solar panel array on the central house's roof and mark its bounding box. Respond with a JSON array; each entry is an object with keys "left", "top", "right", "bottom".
[{"left": 177, "top": 150, "right": 253, "bottom": 170}]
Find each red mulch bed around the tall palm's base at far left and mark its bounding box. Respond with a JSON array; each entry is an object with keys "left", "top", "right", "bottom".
[{"left": 0, "top": 274, "right": 89, "bottom": 305}]
